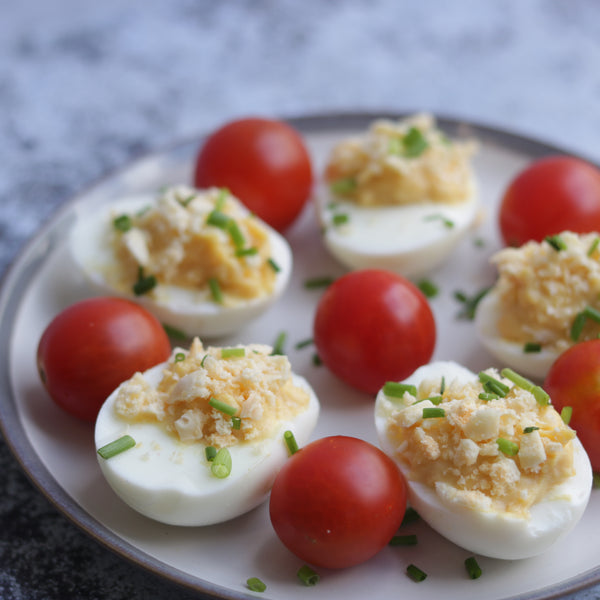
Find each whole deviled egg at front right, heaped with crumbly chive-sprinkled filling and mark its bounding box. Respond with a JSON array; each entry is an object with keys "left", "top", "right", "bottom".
[{"left": 375, "top": 362, "right": 592, "bottom": 559}]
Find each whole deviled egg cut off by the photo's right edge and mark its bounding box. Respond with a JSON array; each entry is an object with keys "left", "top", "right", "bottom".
[{"left": 475, "top": 231, "right": 600, "bottom": 379}]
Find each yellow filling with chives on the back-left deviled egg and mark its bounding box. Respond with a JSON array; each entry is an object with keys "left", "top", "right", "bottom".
[{"left": 106, "top": 185, "right": 276, "bottom": 304}]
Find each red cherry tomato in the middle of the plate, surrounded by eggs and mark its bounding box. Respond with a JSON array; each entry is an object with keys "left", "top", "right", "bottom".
[{"left": 314, "top": 269, "right": 436, "bottom": 394}]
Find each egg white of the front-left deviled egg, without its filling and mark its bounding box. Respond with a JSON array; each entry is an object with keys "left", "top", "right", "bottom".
[{"left": 95, "top": 364, "right": 320, "bottom": 526}]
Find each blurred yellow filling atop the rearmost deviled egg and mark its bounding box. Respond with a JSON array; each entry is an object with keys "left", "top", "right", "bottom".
[{"left": 325, "top": 114, "right": 476, "bottom": 206}]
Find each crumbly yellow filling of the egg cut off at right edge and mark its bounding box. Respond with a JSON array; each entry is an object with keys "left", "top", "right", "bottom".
[{"left": 492, "top": 231, "right": 600, "bottom": 352}]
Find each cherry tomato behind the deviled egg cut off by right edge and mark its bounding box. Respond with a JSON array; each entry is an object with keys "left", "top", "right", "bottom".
[{"left": 499, "top": 156, "right": 600, "bottom": 246}]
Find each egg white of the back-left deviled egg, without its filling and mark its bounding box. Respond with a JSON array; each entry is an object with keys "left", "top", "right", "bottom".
[{"left": 69, "top": 195, "right": 292, "bottom": 338}]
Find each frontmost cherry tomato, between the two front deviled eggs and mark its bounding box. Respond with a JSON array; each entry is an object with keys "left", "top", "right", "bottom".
[{"left": 269, "top": 436, "right": 406, "bottom": 568}]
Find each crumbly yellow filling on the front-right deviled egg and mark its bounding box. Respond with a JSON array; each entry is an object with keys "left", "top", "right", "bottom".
[{"left": 387, "top": 369, "right": 575, "bottom": 515}]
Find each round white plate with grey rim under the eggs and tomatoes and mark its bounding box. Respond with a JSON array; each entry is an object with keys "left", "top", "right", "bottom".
[{"left": 0, "top": 114, "right": 600, "bottom": 600}]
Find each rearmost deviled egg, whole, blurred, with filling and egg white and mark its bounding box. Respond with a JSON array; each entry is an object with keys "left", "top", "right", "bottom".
[{"left": 316, "top": 115, "right": 479, "bottom": 277}]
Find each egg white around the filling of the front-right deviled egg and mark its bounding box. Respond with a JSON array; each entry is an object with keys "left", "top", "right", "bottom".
[{"left": 375, "top": 362, "right": 592, "bottom": 559}]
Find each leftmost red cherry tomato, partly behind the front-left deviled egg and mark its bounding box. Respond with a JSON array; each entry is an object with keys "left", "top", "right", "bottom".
[{"left": 37, "top": 298, "right": 171, "bottom": 421}]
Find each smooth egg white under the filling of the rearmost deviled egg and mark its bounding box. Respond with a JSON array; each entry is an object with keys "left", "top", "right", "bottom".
[{"left": 316, "top": 185, "right": 479, "bottom": 277}]
